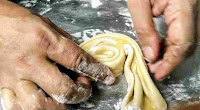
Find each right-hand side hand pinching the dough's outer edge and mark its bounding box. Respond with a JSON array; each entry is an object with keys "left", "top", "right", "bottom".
[{"left": 127, "top": 0, "right": 197, "bottom": 80}]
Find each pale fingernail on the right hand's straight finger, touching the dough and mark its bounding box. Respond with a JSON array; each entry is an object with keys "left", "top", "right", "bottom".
[{"left": 142, "top": 46, "right": 154, "bottom": 62}]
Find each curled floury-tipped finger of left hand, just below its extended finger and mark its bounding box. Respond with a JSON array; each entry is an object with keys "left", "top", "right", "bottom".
[{"left": 31, "top": 61, "right": 91, "bottom": 104}]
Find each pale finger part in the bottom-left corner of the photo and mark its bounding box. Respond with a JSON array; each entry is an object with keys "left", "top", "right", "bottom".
[{"left": 1, "top": 88, "right": 22, "bottom": 110}]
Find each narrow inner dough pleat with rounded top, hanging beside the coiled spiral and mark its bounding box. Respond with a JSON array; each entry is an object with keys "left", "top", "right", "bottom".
[{"left": 121, "top": 44, "right": 143, "bottom": 110}]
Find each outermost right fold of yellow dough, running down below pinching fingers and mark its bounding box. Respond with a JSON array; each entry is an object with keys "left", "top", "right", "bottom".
[{"left": 129, "top": 39, "right": 167, "bottom": 110}]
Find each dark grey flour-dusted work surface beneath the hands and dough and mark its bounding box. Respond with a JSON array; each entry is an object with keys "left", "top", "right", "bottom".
[{"left": 1, "top": 0, "right": 200, "bottom": 110}]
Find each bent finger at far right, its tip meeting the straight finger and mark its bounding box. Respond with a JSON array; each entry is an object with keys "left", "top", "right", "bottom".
[{"left": 150, "top": 0, "right": 195, "bottom": 80}]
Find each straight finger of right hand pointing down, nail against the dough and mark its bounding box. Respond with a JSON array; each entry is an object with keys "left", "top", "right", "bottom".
[{"left": 127, "top": 0, "right": 160, "bottom": 62}]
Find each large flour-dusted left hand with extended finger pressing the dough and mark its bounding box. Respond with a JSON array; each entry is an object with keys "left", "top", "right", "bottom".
[{"left": 0, "top": 0, "right": 115, "bottom": 110}]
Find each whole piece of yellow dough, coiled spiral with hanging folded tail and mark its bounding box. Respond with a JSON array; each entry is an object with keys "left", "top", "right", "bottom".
[{"left": 80, "top": 33, "right": 167, "bottom": 110}]
